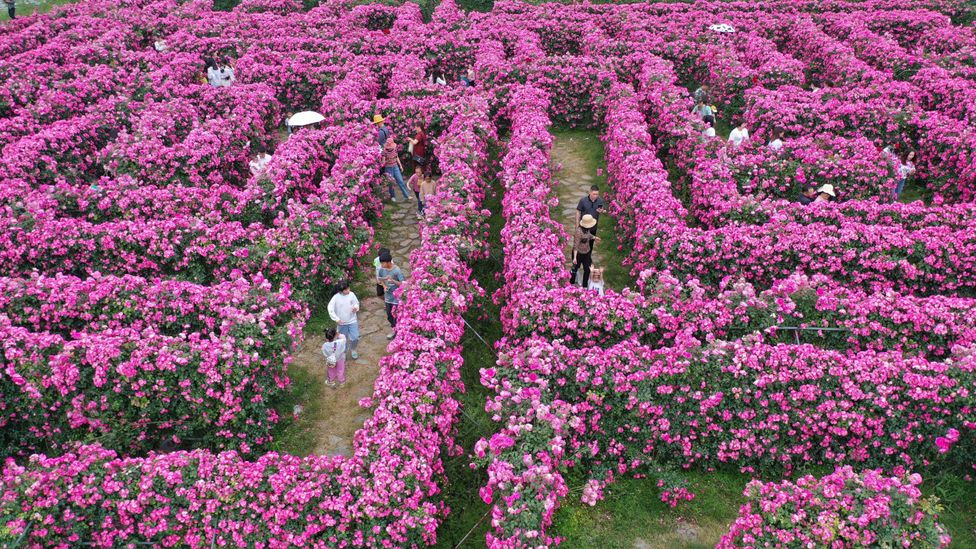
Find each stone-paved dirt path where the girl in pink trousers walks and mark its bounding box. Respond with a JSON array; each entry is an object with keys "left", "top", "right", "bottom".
[{"left": 290, "top": 192, "right": 420, "bottom": 456}]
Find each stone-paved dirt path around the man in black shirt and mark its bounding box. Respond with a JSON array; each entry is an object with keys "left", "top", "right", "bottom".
[{"left": 552, "top": 132, "right": 610, "bottom": 278}]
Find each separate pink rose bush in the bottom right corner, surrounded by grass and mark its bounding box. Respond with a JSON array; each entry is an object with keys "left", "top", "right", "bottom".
[{"left": 717, "top": 467, "right": 951, "bottom": 549}]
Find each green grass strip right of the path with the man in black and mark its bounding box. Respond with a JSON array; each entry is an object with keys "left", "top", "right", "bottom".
[{"left": 552, "top": 128, "right": 634, "bottom": 290}]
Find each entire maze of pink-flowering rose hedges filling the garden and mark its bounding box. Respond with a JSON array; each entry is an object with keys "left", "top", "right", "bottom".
[{"left": 0, "top": 0, "right": 976, "bottom": 548}]
